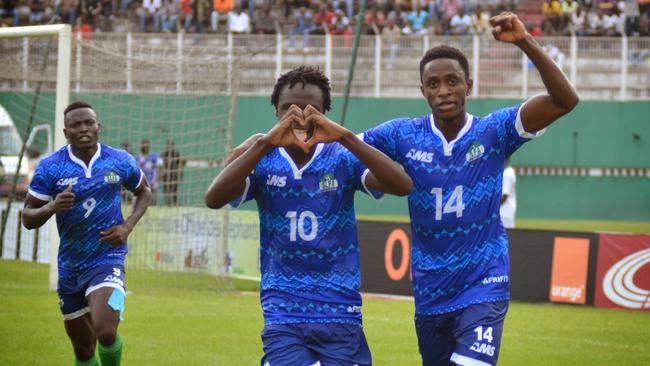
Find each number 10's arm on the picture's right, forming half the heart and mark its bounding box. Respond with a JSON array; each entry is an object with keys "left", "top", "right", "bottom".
[{"left": 304, "top": 105, "right": 413, "bottom": 196}]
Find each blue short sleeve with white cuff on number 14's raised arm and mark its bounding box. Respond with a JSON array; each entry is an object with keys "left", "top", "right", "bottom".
[{"left": 488, "top": 104, "right": 546, "bottom": 157}]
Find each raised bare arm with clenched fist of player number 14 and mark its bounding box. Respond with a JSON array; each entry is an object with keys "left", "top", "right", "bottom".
[{"left": 490, "top": 12, "right": 579, "bottom": 133}]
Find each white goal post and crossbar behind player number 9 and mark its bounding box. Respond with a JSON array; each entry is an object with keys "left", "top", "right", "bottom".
[{"left": 0, "top": 24, "right": 72, "bottom": 290}]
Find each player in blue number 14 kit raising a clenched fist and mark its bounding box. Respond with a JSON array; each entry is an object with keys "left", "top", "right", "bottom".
[{"left": 364, "top": 13, "right": 578, "bottom": 366}]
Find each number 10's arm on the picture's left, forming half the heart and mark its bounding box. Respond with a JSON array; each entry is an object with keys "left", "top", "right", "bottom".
[{"left": 205, "top": 105, "right": 308, "bottom": 208}]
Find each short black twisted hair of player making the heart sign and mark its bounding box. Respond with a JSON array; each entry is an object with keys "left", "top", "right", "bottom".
[{"left": 271, "top": 66, "right": 332, "bottom": 112}]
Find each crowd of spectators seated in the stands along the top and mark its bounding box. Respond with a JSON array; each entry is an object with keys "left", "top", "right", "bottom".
[{"left": 0, "top": 0, "right": 650, "bottom": 36}]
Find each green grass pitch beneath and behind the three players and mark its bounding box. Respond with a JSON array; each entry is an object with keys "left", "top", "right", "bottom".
[{"left": 0, "top": 260, "right": 650, "bottom": 366}]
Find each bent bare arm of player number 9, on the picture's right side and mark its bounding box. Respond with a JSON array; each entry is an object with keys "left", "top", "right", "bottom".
[{"left": 99, "top": 169, "right": 151, "bottom": 245}]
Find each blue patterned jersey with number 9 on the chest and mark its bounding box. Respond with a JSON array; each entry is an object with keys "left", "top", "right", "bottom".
[{"left": 29, "top": 144, "right": 143, "bottom": 278}]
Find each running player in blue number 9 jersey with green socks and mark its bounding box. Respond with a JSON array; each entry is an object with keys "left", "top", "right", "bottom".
[{"left": 23, "top": 102, "right": 151, "bottom": 366}]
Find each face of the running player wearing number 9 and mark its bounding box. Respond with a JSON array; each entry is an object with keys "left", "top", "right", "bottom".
[{"left": 63, "top": 108, "right": 101, "bottom": 149}]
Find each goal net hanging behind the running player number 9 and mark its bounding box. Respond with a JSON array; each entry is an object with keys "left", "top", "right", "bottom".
[{"left": 0, "top": 27, "right": 253, "bottom": 290}]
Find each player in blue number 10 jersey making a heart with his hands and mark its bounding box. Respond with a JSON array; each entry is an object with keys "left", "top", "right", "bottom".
[{"left": 205, "top": 66, "right": 412, "bottom": 366}]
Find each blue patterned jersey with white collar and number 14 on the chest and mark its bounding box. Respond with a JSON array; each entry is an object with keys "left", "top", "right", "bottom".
[{"left": 364, "top": 106, "right": 543, "bottom": 315}]
